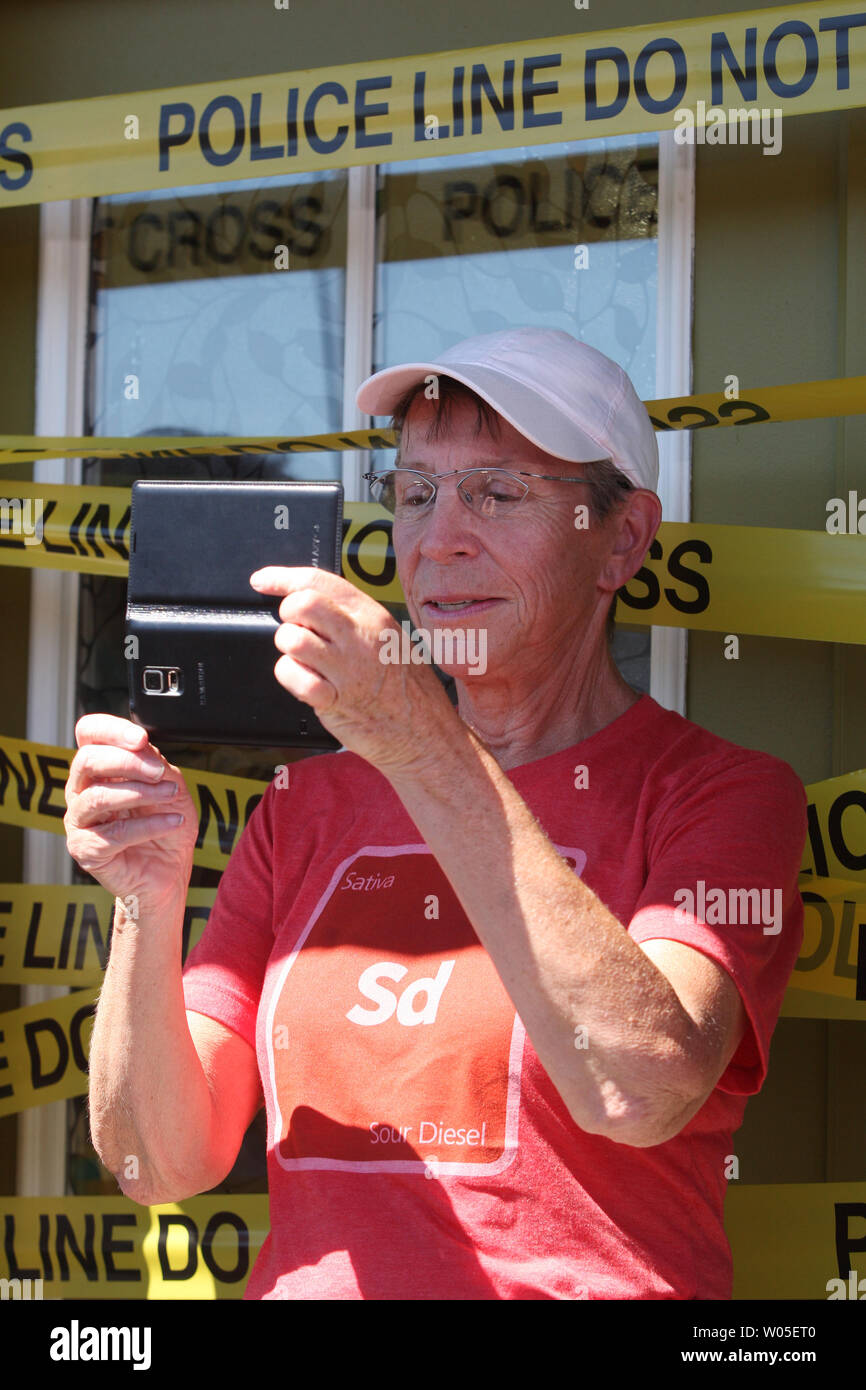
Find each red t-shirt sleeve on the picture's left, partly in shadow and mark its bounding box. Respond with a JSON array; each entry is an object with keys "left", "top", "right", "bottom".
[{"left": 183, "top": 783, "right": 274, "bottom": 1048}]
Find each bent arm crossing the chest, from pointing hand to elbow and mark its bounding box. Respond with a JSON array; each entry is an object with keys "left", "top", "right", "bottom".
[{"left": 253, "top": 567, "right": 744, "bottom": 1147}]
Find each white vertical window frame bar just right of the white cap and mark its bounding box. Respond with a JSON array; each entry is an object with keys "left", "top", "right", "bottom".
[{"left": 650, "top": 131, "right": 695, "bottom": 714}]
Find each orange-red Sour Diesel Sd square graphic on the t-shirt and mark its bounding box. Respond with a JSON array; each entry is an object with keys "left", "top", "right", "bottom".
[{"left": 265, "top": 845, "right": 587, "bottom": 1176}]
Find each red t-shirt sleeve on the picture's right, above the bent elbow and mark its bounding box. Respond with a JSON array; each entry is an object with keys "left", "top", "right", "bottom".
[{"left": 628, "top": 753, "right": 806, "bottom": 1095}]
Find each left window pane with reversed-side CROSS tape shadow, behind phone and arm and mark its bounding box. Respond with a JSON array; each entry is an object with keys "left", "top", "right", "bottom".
[{"left": 68, "top": 171, "right": 348, "bottom": 1194}]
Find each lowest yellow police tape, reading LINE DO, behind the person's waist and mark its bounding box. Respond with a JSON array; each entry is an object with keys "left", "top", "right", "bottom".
[{"left": 0, "top": 1184, "right": 866, "bottom": 1301}]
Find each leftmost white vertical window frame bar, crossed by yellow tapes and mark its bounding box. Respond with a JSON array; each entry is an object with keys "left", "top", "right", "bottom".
[{"left": 17, "top": 199, "right": 92, "bottom": 1197}]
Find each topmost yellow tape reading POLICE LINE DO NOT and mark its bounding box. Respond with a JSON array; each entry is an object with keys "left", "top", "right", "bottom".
[{"left": 0, "top": 3, "right": 866, "bottom": 207}]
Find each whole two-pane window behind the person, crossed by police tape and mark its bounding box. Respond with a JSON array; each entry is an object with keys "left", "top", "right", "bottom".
[{"left": 31, "top": 127, "right": 691, "bottom": 1193}]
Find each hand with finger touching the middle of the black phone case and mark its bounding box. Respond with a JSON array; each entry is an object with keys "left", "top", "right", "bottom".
[{"left": 250, "top": 566, "right": 459, "bottom": 776}]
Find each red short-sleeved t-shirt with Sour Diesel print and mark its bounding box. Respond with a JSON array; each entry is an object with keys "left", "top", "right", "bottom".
[{"left": 183, "top": 695, "right": 806, "bottom": 1300}]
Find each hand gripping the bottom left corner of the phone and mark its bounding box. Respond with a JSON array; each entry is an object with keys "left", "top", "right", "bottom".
[{"left": 64, "top": 714, "right": 197, "bottom": 908}]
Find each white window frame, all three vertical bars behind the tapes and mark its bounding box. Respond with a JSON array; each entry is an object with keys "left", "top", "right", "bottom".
[{"left": 17, "top": 132, "right": 695, "bottom": 1197}]
